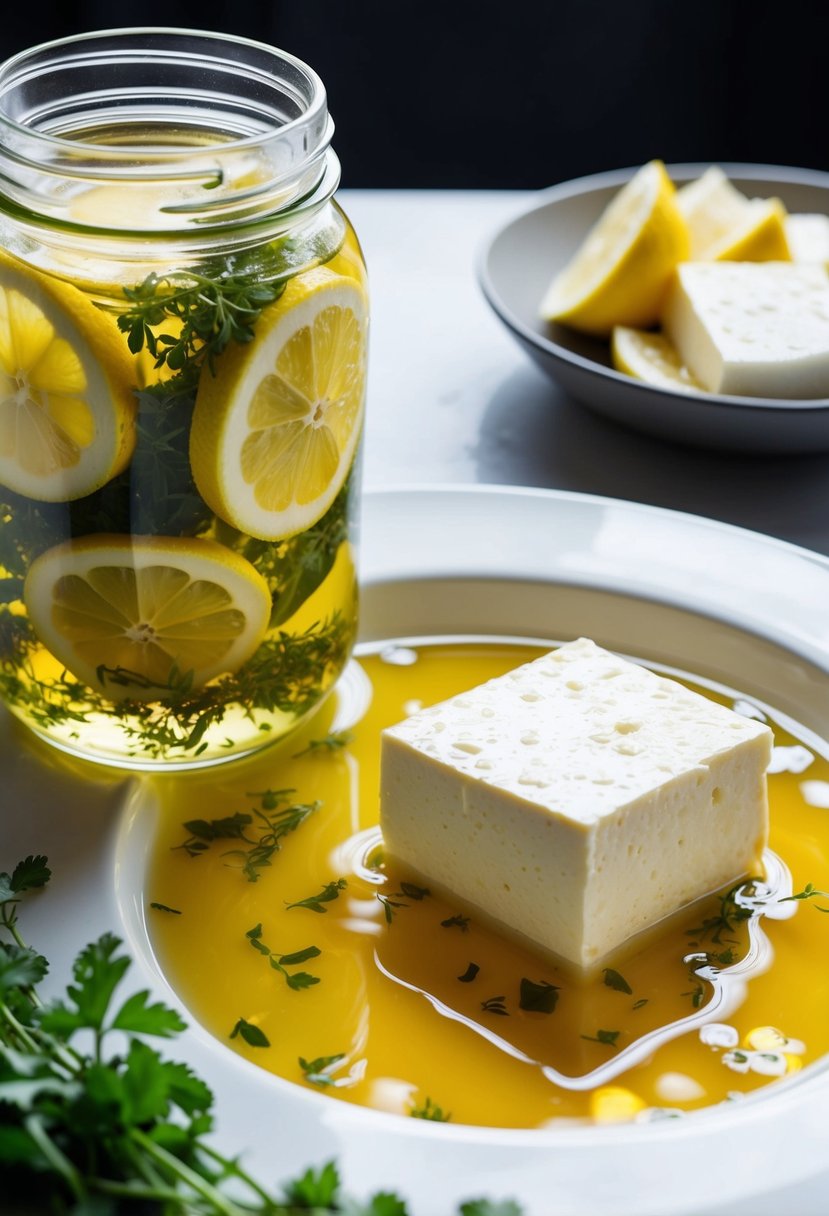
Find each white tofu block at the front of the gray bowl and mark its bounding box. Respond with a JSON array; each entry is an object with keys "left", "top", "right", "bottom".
[{"left": 662, "top": 261, "right": 829, "bottom": 399}]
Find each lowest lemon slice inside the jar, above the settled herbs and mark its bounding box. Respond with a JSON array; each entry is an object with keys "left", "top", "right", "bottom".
[{"left": 23, "top": 535, "right": 271, "bottom": 700}]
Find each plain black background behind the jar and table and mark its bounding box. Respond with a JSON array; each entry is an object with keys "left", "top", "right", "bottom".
[{"left": 0, "top": 0, "right": 829, "bottom": 188}]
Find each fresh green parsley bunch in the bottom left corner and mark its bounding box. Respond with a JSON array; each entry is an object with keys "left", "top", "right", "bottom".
[{"left": 0, "top": 856, "right": 520, "bottom": 1216}]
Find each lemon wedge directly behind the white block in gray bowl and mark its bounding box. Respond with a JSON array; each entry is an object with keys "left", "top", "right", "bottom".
[{"left": 677, "top": 164, "right": 791, "bottom": 261}]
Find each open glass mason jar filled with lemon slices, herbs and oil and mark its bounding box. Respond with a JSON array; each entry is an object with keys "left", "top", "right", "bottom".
[{"left": 0, "top": 29, "right": 368, "bottom": 769}]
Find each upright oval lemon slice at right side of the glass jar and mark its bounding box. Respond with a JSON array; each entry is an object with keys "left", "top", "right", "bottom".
[{"left": 190, "top": 266, "right": 368, "bottom": 540}]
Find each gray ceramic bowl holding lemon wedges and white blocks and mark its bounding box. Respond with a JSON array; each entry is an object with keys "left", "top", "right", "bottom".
[{"left": 478, "top": 164, "right": 829, "bottom": 454}]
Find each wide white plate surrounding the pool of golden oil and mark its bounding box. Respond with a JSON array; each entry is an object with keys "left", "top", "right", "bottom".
[{"left": 0, "top": 486, "right": 829, "bottom": 1216}]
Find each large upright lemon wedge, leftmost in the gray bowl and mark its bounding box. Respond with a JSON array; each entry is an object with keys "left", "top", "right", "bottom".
[{"left": 540, "top": 161, "right": 688, "bottom": 336}]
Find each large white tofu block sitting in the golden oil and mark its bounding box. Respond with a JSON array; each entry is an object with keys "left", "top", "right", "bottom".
[{"left": 380, "top": 638, "right": 772, "bottom": 970}]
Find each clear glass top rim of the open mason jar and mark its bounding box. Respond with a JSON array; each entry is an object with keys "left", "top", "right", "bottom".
[{"left": 0, "top": 26, "right": 331, "bottom": 154}]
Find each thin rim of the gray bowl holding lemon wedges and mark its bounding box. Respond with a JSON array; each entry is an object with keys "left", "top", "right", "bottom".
[{"left": 475, "top": 161, "right": 829, "bottom": 415}]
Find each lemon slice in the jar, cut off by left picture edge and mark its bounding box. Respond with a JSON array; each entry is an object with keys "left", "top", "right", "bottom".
[{"left": 0, "top": 255, "right": 135, "bottom": 502}]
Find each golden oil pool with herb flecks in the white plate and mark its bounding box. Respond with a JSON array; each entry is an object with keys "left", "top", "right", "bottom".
[{"left": 146, "top": 641, "right": 829, "bottom": 1127}]
